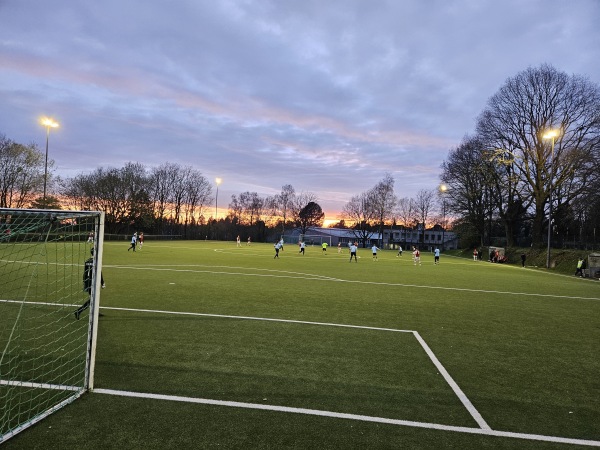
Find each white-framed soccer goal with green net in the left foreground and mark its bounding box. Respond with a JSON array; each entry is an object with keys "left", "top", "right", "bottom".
[{"left": 0, "top": 208, "right": 104, "bottom": 444}]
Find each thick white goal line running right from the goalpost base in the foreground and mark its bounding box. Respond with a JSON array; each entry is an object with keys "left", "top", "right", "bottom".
[{"left": 93, "top": 389, "right": 600, "bottom": 447}]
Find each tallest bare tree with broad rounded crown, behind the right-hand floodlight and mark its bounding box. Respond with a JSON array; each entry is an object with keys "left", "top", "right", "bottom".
[{"left": 477, "top": 64, "right": 600, "bottom": 246}]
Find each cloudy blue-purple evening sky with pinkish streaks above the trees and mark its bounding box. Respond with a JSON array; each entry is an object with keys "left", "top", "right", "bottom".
[{"left": 0, "top": 0, "right": 600, "bottom": 220}]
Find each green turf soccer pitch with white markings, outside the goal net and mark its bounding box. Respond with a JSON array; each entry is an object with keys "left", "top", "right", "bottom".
[{"left": 3, "top": 241, "right": 600, "bottom": 449}]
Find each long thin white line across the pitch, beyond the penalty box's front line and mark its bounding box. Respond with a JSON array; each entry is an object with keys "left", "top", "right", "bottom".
[{"left": 104, "top": 265, "right": 600, "bottom": 301}]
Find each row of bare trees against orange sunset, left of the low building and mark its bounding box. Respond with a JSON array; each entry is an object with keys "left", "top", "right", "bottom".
[{"left": 0, "top": 145, "right": 325, "bottom": 241}]
